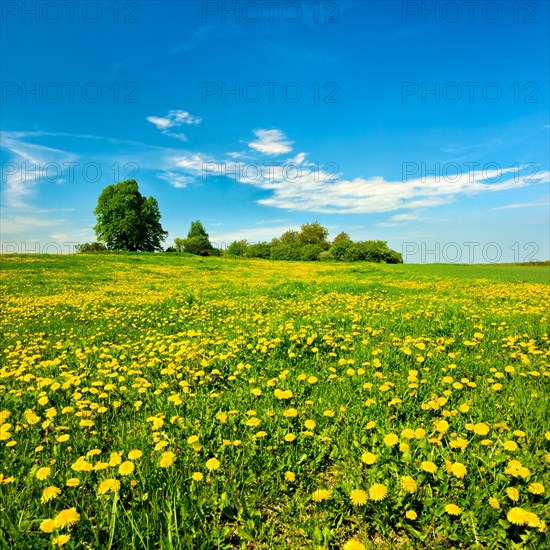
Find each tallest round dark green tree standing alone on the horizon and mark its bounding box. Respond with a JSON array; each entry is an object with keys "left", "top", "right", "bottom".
[{"left": 94, "top": 180, "right": 168, "bottom": 252}]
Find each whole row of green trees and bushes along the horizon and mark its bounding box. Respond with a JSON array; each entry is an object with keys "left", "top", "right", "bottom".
[{"left": 78, "top": 180, "right": 403, "bottom": 263}]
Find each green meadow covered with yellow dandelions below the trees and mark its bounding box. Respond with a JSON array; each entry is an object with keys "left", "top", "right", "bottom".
[{"left": 0, "top": 254, "right": 550, "bottom": 550}]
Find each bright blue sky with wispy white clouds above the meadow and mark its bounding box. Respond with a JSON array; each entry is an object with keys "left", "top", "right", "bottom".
[{"left": 0, "top": 0, "right": 550, "bottom": 262}]
